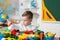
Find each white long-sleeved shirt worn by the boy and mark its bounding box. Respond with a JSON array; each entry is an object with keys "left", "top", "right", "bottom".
[{"left": 8, "top": 23, "right": 37, "bottom": 31}]
